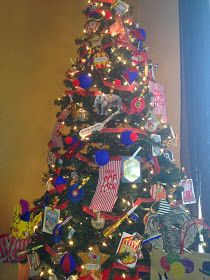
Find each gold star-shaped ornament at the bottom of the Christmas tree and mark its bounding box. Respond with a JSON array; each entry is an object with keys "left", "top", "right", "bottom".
[{"left": 78, "top": 245, "right": 109, "bottom": 279}]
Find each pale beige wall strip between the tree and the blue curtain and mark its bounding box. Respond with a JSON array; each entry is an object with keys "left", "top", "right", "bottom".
[{"left": 138, "top": 0, "right": 181, "bottom": 164}]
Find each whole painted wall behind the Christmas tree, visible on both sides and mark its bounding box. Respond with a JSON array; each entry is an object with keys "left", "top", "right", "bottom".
[{"left": 0, "top": 0, "right": 180, "bottom": 233}]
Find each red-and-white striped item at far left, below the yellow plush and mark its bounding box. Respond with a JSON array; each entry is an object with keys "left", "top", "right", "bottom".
[{"left": 0, "top": 234, "right": 31, "bottom": 263}]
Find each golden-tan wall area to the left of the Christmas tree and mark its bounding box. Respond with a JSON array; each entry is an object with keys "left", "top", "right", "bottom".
[{"left": 0, "top": 0, "right": 85, "bottom": 233}]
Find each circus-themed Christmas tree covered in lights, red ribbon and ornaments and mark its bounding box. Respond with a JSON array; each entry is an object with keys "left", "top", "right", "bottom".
[{"left": 6, "top": 0, "right": 207, "bottom": 280}]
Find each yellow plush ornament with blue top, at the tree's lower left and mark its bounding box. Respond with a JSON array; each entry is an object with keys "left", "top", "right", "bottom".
[{"left": 11, "top": 200, "right": 42, "bottom": 239}]
